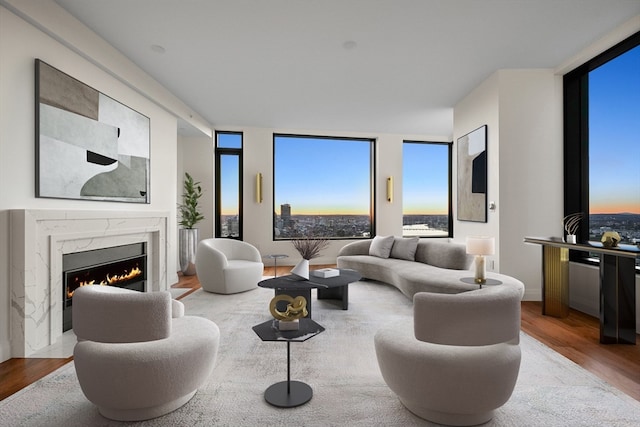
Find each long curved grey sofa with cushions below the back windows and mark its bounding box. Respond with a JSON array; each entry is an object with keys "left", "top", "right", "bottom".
[{"left": 337, "top": 236, "right": 522, "bottom": 299}]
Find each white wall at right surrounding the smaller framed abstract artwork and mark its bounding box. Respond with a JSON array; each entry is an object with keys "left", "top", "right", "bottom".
[{"left": 454, "top": 69, "right": 640, "bottom": 330}]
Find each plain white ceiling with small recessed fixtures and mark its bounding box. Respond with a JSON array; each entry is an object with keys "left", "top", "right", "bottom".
[{"left": 56, "top": 0, "right": 640, "bottom": 138}]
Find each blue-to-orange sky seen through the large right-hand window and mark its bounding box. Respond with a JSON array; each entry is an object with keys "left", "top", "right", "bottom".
[{"left": 589, "top": 46, "right": 640, "bottom": 214}]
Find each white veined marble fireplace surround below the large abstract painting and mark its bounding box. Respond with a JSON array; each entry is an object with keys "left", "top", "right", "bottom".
[{"left": 10, "top": 209, "right": 169, "bottom": 357}]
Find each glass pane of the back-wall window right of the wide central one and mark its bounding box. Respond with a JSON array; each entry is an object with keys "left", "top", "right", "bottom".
[{"left": 402, "top": 141, "right": 450, "bottom": 237}]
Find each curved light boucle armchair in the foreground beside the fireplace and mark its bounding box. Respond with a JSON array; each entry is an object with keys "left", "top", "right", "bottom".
[{"left": 73, "top": 285, "right": 220, "bottom": 421}]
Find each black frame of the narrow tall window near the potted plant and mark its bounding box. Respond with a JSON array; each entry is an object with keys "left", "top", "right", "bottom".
[{"left": 214, "top": 131, "right": 244, "bottom": 240}]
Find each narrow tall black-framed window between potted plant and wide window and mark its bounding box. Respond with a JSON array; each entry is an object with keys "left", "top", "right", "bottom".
[{"left": 215, "top": 132, "right": 242, "bottom": 239}]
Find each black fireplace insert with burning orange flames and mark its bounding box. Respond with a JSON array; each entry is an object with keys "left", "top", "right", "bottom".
[{"left": 62, "top": 243, "right": 147, "bottom": 332}]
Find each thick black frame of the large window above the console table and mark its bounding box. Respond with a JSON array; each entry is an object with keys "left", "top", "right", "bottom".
[{"left": 563, "top": 32, "right": 640, "bottom": 264}]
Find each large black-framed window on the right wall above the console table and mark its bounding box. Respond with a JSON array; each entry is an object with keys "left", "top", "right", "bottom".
[{"left": 564, "top": 33, "right": 640, "bottom": 268}]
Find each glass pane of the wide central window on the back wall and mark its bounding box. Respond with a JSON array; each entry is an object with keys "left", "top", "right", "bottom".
[{"left": 274, "top": 135, "right": 373, "bottom": 240}]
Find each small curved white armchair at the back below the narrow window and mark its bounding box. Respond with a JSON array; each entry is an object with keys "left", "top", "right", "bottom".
[{"left": 196, "top": 239, "right": 264, "bottom": 294}]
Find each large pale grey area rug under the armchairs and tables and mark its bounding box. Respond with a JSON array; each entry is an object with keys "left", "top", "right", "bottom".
[{"left": 0, "top": 281, "right": 640, "bottom": 427}]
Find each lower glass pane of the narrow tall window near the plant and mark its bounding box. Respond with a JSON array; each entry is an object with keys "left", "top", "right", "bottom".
[{"left": 219, "top": 154, "right": 240, "bottom": 237}]
